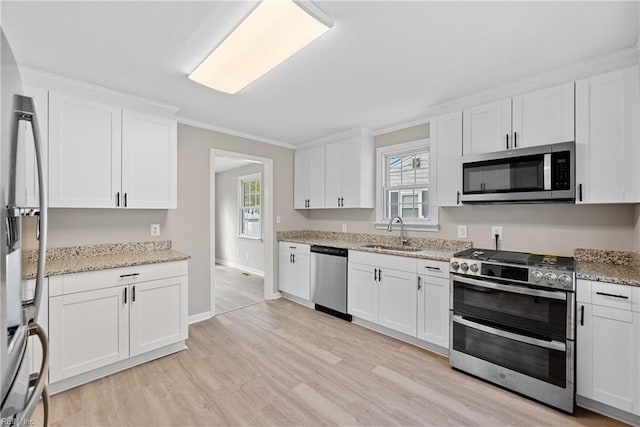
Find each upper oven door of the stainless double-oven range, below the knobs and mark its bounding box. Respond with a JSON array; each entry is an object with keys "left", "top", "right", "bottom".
[{"left": 451, "top": 274, "right": 571, "bottom": 339}]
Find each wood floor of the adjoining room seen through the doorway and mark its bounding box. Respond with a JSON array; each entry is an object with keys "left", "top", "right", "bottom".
[{"left": 215, "top": 264, "right": 264, "bottom": 314}]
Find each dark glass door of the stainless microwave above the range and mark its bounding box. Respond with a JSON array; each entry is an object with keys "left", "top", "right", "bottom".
[{"left": 462, "top": 154, "right": 550, "bottom": 194}]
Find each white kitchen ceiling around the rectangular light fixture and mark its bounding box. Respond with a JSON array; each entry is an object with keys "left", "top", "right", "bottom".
[{"left": 2, "top": 1, "right": 638, "bottom": 144}]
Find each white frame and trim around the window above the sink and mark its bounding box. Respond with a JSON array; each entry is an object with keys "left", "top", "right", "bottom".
[{"left": 374, "top": 138, "right": 440, "bottom": 231}]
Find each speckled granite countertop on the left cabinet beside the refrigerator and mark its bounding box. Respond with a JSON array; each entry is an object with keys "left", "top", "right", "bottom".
[{"left": 22, "top": 240, "right": 190, "bottom": 279}]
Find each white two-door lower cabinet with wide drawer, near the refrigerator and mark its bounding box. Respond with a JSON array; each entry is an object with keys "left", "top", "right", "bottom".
[{"left": 49, "top": 261, "right": 188, "bottom": 383}]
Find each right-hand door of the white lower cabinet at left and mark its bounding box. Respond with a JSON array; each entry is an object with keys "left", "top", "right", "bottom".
[{"left": 130, "top": 276, "right": 188, "bottom": 356}]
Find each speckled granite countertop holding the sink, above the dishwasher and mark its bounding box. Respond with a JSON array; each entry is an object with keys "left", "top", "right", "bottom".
[{"left": 277, "top": 230, "right": 472, "bottom": 261}]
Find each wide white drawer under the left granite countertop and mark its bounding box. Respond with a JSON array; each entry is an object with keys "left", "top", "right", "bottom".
[{"left": 49, "top": 261, "right": 187, "bottom": 296}]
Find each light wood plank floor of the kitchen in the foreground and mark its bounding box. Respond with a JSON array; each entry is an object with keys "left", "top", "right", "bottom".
[{"left": 31, "top": 299, "right": 619, "bottom": 427}]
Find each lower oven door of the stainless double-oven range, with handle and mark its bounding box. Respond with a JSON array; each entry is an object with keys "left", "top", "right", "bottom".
[{"left": 452, "top": 314, "right": 567, "bottom": 388}]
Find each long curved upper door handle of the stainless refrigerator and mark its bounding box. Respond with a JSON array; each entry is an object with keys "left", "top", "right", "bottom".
[{"left": 15, "top": 96, "right": 48, "bottom": 324}]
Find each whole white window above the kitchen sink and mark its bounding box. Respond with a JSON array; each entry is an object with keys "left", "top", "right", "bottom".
[{"left": 376, "top": 139, "right": 438, "bottom": 230}]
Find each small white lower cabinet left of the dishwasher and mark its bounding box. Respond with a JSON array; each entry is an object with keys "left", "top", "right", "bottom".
[{"left": 278, "top": 242, "right": 311, "bottom": 300}]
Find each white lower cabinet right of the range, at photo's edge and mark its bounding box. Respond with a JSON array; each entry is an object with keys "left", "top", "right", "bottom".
[{"left": 576, "top": 280, "right": 640, "bottom": 415}]
